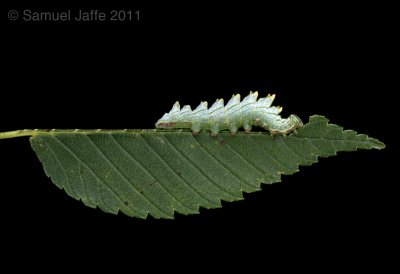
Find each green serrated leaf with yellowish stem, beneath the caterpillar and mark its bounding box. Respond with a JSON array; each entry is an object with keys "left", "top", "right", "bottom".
[{"left": 0, "top": 116, "right": 385, "bottom": 218}]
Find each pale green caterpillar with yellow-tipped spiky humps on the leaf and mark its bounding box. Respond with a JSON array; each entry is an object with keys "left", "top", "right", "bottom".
[{"left": 156, "top": 91, "right": 303, "bottom": 136}]
